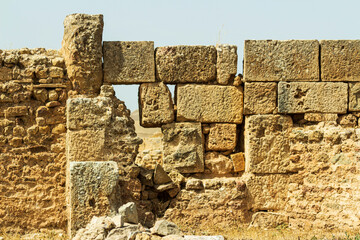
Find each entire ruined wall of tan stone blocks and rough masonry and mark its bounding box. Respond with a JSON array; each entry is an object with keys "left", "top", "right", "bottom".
[{"left": 0, "top": 14, "right": 360, "bottom": 236}]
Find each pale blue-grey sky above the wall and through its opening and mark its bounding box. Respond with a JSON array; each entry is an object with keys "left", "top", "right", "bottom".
[{"left": 0, "top": 0, "right": 360, "bottom": 110}]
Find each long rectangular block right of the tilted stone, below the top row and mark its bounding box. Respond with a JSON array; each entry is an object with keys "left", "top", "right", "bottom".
[{"left": 176, "top": 84, "right": 243, "bottom": 123}]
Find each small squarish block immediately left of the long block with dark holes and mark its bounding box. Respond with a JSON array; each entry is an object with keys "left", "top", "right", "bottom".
[{"left": 244, "top": 82, "right": 277, "bottom": 114}]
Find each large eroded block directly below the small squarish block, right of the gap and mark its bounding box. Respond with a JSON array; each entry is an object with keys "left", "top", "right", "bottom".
[{"left": 245, "top": 115, "right": 297, "bottom": 173}]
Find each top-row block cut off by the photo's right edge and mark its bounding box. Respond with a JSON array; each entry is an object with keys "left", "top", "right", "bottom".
[{"left": 320, "top": 40, "right": 360, "bottom": 81}]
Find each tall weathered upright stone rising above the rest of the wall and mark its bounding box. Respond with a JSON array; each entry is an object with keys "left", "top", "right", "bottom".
[{"left": 61, "top": 14, "right": 104, "bottom": 95}]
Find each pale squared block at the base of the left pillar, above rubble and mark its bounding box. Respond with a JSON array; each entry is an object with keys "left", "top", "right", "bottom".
[{"left": 68, "top": 161, "right": 119, "bottom": 233}]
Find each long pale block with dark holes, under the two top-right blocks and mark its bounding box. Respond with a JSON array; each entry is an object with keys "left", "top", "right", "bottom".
[{"left": 278, "top": 82, "right": 348, "bottom": 113}]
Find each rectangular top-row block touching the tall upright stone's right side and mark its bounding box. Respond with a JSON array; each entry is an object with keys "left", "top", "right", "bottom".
[{"left": 104, "top": 41, "right": 155, "bottom": 84}]
